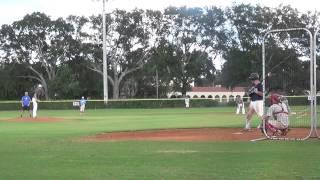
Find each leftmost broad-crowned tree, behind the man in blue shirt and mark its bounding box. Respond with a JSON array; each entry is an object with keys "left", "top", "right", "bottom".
[{"left": 0, "top": 13, "right": 73, "bottom": 99}]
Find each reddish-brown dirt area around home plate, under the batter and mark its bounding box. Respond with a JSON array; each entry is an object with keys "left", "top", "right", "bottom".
[{"left": 82, "top": 128, "right": 308, "bottom": 141}]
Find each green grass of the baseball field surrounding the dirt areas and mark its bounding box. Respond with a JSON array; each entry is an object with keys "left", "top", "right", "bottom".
[{"left": 0, "top": 108, "right": 320, "bottom": 180}]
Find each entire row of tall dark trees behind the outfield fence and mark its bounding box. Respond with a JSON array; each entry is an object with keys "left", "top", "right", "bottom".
[{"left": 0, "top": 4, "right": 319, "bottom": 99}]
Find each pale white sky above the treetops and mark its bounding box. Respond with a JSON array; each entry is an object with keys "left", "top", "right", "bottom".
[{"left": 0, "top": 0, "right": 320, "bottom": 24}]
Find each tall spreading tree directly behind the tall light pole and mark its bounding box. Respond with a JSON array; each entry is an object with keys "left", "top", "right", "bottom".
[{"left": 82, "top": 10, "right": 151, "bottom": 99}]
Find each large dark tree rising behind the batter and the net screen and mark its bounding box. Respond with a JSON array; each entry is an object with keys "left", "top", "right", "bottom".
[{"left": 222, "top": 4, "right": 310, "bottom": 91}]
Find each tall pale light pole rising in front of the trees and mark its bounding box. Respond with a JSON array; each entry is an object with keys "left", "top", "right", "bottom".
[{"left": 102, "top": 0, "right": 109, "bottom": 104}]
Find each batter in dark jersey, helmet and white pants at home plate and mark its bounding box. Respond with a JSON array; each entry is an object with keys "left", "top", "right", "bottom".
[{"left": 244, "top": 73, "right": 263, "bottom": 131}]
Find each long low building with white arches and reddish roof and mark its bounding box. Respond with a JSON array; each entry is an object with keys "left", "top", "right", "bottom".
[{"left": 168, "top": 86, "right": 246, "bottom": 102}]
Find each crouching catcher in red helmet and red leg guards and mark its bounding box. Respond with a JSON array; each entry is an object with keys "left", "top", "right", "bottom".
[{"left": 263, "top": 94, "right": 289, "bottom": 136}]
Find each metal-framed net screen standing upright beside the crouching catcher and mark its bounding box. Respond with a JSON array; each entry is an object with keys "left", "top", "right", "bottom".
[{"left": 262, "top": 28, "right": 313, "bottom": 140}]
